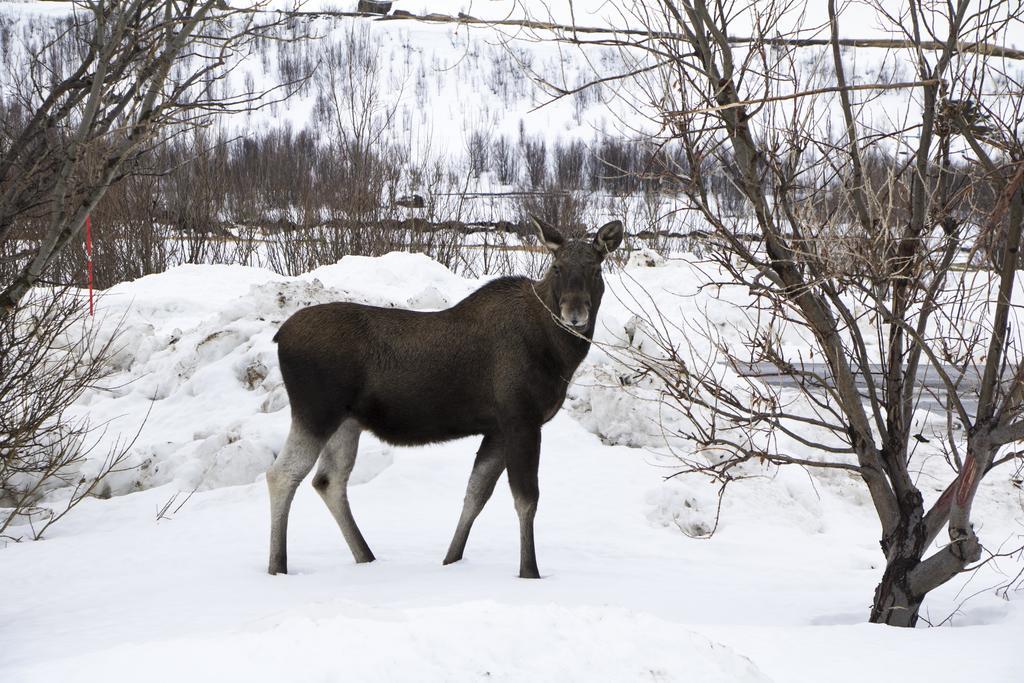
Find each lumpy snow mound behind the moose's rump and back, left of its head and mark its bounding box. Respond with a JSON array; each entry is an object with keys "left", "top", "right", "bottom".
[{"left": 69, "top": 254, "right": 475, "bottom": 495}]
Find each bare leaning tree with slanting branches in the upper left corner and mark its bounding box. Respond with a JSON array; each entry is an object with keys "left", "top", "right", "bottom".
[{"left": 0, "top": 0, "right": 303, "bottom": 315}]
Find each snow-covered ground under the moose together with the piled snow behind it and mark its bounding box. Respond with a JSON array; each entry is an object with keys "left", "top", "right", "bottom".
[{"left": 0, "top": 254, "right": 1024, "bottom": 682}]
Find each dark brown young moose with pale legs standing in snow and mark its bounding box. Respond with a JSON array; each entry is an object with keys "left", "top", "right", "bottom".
[{"left": 266, "top": 218, "right": 623, "bottom": 579}]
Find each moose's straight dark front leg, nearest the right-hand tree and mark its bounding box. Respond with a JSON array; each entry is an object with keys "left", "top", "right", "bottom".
[{"left": 505, "top": 426, "right": 541, "bottom": 579}]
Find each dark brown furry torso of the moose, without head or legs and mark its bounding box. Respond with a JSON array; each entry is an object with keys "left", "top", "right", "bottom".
[{"left": 276, "top": 278, "right": 593, "bottom": 445}]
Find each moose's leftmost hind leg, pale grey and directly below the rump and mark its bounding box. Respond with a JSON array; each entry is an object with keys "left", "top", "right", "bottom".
[{"left": 266, "top": 420, "right": 324, "bottom": 574}]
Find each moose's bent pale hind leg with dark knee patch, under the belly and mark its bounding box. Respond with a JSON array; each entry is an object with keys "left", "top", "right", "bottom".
[{"left": 313, "top": 420, "right": 374, "bottom": 562}]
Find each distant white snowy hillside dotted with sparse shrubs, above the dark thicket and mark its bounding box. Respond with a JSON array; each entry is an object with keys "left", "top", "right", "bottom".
[{"left": 6, "top": 0, "right": 1024, "bottom": 184}]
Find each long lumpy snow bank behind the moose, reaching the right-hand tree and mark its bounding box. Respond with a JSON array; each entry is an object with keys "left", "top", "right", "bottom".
[{"left": 29, "top": 250, "right": 999, "bottom": 537}]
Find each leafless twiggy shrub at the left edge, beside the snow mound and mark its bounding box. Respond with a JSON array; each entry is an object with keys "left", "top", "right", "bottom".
[{"left": 0, "top": 289, "right": 131, "bottom": 541}]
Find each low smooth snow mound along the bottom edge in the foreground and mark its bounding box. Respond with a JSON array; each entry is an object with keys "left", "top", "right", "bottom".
[{"left": 8, "top": 602, "right": 770, "bottom": 683}]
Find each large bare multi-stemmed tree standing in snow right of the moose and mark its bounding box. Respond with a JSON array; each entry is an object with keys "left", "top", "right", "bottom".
[{"left": 520, "top": 0, "right": 1024, "bottom": 626}]
